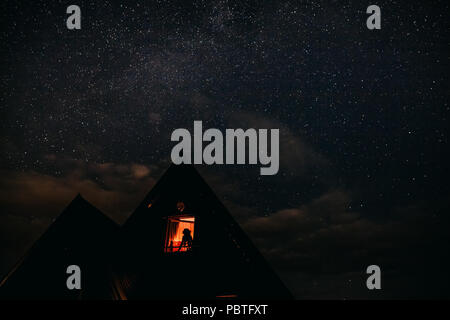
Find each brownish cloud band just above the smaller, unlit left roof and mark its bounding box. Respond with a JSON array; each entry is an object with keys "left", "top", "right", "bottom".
[{"left": 0, "top": 157, "right": 156, "bottom": 222}]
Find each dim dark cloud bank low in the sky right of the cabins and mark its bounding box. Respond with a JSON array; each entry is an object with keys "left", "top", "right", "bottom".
[{"left": 237, "top": 190, "right": 450, "bottom": 299}]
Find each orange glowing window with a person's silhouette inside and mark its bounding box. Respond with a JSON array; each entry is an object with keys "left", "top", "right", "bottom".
[{"left": 164, "top": 215, "right": 195, "bottom": 252}]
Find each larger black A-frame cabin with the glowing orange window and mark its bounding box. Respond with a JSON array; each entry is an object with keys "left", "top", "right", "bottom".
[{"left": 114, "top": 165, "right": 292, "bottom": 299}]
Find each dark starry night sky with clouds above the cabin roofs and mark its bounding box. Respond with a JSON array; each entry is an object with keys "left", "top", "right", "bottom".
[{"left": 0, "top": 0, "right": 450, "bottom": 299}]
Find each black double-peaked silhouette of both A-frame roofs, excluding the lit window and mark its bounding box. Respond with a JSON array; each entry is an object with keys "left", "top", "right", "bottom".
[{"left": 0, "top": 165, "right": 292, "bottom": 299}]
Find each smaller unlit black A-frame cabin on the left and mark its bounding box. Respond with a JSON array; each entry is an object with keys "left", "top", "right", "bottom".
[{"left": 0, "top": 195, "right": 119, "bottom": 300}]
